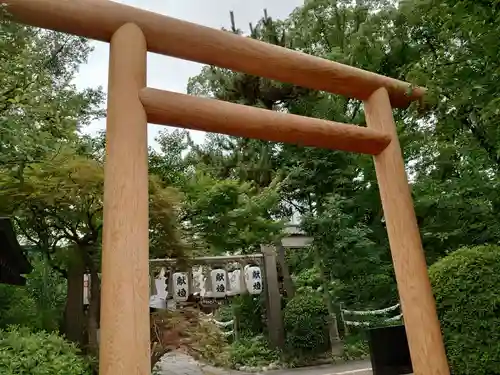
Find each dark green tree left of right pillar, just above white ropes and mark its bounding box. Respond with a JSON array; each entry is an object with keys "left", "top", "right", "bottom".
[{"left": 303, "top": 195, "right": 397, "bottom": 308}]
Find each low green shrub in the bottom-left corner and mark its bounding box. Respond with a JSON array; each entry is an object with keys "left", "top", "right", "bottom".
[{"left": 0, "top": 326, "right": 91, "bottom": 375}]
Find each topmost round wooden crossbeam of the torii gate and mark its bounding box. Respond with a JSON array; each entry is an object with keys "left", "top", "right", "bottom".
[{"left": 0, "top": 0, "right": 425, "bottom": 107}]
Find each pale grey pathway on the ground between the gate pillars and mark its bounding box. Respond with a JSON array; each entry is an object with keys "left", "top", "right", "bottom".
[{"left": 157, "top": 351, "right": 372, "bottom": 375}]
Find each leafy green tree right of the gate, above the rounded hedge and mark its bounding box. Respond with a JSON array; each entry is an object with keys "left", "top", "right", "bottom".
[{"left": 401, "top": 0, "right": 500, "bottom": 262}]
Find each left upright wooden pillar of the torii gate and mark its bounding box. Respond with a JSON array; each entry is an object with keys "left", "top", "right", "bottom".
[{"left": 99, "top": 24, "right": 150, "bottom": 375}]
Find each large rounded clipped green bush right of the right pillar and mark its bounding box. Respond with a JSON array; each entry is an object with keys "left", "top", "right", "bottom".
[{"left": 429, "top": 246, "right": 500, "bottom": 375}]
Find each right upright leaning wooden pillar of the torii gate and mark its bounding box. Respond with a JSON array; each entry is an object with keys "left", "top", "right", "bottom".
[{"left": 365, "top": 88, "right": 450, "bottom": 375}]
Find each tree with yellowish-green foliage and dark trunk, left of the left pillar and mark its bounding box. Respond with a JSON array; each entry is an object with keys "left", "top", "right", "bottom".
[{"left": 0, "top": 149, "right": 103, "bottom": 343}]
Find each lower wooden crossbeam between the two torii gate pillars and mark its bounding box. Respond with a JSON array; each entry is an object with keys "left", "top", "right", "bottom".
[{"left": 140, "top": 88, "right": 391, "bottom": 155}]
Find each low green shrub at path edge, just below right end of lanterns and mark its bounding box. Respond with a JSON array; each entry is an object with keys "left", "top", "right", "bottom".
[{"left": 230, "top": 336, "right": 279, "bottom": 368}]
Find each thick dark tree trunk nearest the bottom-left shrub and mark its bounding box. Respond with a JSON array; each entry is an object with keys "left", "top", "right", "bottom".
[{"left": 64, "top": 251, "right": 85, "bottom": 347}]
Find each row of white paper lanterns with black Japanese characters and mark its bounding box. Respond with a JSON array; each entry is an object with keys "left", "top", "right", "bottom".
[{"left": 155, "top": 265, "right": 263, "bottom": 302}]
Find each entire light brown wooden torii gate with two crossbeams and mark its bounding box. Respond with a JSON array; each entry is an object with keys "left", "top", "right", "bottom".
[{"left": 0, "top": 0, "right": 449, "bottom": 375}]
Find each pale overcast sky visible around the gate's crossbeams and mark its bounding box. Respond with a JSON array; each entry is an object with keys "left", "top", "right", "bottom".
[{"left": 75, "top": 0, "right": 304, "bottom": 147}]
